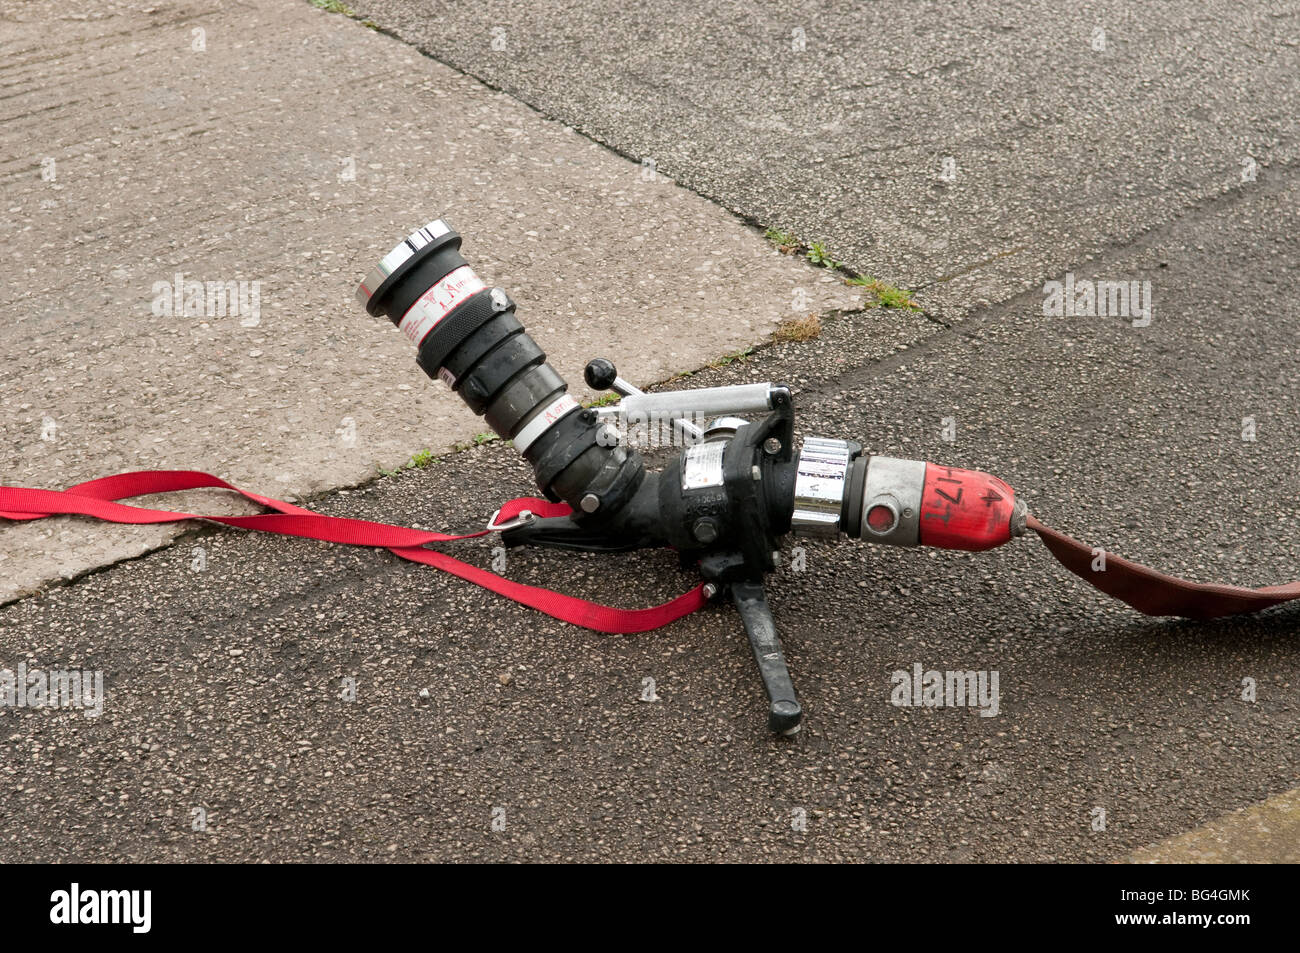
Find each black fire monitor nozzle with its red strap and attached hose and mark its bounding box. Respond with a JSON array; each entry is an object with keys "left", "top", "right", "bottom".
[{"left": 0, "top": 220, "right": 1300, "bottom": 735}]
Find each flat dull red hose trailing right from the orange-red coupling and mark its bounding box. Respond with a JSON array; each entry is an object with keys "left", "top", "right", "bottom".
[{"left": 1027, "top": 516, "right": 1300, "bottom": 619}]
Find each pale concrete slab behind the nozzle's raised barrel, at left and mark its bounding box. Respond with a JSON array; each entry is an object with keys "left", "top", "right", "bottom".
[{"left": 0, "top": 0, "right": 857, "bottom": 601}]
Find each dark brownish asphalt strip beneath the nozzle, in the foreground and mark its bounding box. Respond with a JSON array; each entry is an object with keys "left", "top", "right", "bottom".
[{"left": 0, "top": 163, "right": 1300, "bottom": 861}]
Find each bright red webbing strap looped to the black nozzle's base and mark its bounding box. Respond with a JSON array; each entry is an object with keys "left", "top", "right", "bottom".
[{"left": 0, "top": 469, "right": 707, "bottom": 634}]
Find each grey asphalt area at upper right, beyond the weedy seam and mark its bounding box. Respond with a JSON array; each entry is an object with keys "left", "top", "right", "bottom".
[{"left": 350, "top": 0, "right": 1300, "bottom": 320}]
